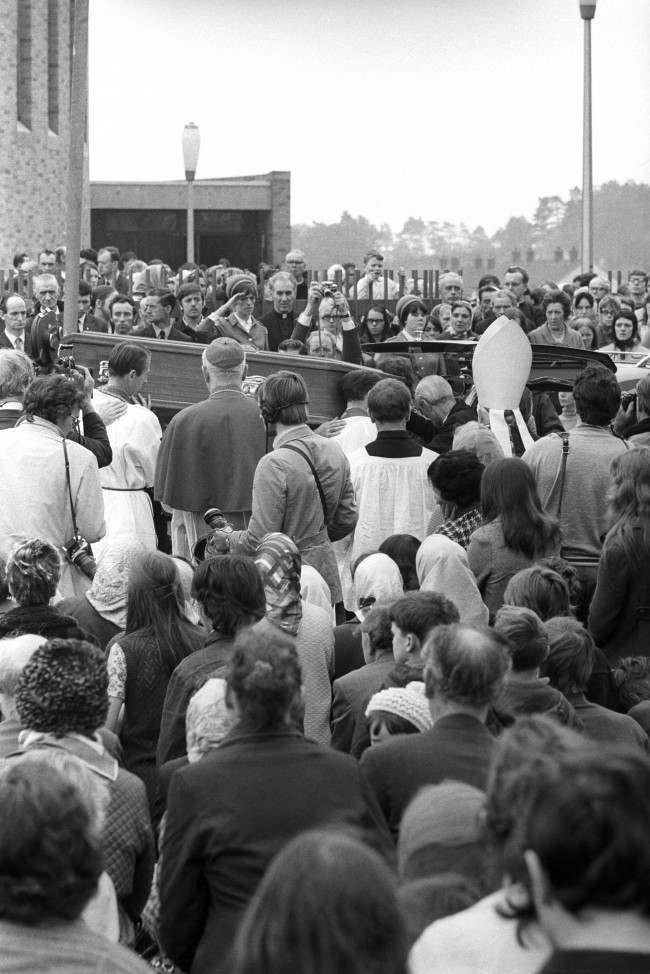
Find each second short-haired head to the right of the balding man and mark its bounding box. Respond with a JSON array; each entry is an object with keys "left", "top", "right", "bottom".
[{"left": 544, "top": 616, "right": 596, "bottom": 696}]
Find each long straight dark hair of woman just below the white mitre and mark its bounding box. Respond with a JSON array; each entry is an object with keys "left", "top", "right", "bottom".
[{"left": 481, "top": 457, "right": 560, "bottom": 559}]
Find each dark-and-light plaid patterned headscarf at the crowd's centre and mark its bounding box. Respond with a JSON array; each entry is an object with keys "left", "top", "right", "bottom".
[{"left": 255, "top": 531, "right": 302, "bottom": 636}]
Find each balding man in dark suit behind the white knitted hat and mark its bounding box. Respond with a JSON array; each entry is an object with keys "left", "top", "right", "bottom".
[{"left": 361, "top": 625, "right": 510, "bottom": 836}]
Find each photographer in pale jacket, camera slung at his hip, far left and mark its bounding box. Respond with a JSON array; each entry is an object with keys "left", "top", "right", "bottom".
[{"left": 0, "top": 375, "right": 105, "bottom": 597}]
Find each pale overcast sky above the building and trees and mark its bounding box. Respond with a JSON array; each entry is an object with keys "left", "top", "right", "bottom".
[{"left": 89, "top": 0, "right": 650, "bottom": 233}]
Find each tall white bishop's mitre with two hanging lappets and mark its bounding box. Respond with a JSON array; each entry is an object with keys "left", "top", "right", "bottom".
[{"left": 472, "top": 315, "right": 533, "bottom": 457}]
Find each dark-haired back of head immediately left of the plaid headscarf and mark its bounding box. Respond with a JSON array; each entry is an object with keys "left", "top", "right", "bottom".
[{"left": 192, "top": 555, "right": 266, "bottom": 639}]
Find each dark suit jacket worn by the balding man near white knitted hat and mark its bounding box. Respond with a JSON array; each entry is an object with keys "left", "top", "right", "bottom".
[{"left": 361, "top": 714, "right": 495, "bottom": 836}]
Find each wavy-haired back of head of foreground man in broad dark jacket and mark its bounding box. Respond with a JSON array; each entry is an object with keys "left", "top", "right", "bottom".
[{"left": 226, "top": 628, "right": 302, "bottom": 731}]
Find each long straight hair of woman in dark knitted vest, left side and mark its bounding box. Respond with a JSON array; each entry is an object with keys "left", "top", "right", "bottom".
[{"left": 125, "top": 551, "right": 195, "bottom": 674}]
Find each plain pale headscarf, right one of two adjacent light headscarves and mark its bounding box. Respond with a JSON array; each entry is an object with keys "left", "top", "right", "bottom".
[{"left": 415, "top": 534, "right": 489, "bottom": 626}]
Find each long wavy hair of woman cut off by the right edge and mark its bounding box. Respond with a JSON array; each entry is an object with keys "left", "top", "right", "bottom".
[{"left": 607, "top": 447, "right": 650, "bottom": 565}]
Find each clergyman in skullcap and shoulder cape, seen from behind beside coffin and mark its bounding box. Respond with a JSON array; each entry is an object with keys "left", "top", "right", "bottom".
[{"left": 154, "top": 337, "right": 266, "bottom": 558}]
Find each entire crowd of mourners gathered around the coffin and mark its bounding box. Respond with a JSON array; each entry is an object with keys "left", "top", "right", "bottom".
[{"left": 0, "top": 240, "right": 650, "bottom": 974}]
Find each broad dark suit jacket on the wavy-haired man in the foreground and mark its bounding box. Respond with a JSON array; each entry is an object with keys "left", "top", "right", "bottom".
[{"left": 159, "top": 729, "right": 390, "bottom": 974}]
